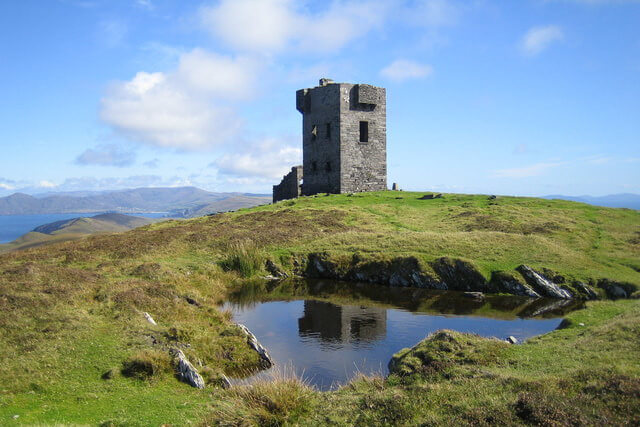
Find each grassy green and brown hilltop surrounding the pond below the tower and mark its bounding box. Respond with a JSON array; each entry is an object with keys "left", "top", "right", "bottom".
[{"left": 0, "top": 192, "right": 640, "bottom": 425}]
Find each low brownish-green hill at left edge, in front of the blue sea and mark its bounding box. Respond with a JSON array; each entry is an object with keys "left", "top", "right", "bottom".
[{"left": 0, "top": 213, "right": 159, "bottom": 253}]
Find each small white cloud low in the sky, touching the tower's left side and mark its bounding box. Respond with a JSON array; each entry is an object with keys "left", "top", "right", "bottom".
[{"left": 210, "top": 139, "right": 302, "bottom": 183}]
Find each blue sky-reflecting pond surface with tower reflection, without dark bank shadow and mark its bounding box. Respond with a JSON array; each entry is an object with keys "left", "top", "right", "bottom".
[{"left": 228, "top": 300, "right": 561, "bottom": 390}]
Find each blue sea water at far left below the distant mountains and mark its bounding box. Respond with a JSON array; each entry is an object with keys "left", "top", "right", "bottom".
[{"left": 0, "top": 212, "right": 168, "bottom": 244}]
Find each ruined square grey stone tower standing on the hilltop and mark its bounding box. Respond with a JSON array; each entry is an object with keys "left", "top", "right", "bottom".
[{"left": 273, "top": 79, "right": 387, "bottom": 202}]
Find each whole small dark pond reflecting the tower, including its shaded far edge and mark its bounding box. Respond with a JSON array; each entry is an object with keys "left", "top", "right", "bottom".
[{"left": 224, "top": 280, "right": 582, "bottom": 390}]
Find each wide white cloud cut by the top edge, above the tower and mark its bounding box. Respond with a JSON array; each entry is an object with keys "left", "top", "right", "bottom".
[{"left": 200, "top": 0, "right": 391, "bottom": 53}]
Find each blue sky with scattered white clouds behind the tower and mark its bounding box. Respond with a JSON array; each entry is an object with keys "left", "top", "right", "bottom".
[{"left": 0, "top": 0, "right": 640, "bottom": 196}]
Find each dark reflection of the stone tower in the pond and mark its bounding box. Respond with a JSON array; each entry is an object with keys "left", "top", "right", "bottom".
[{"left": 298, "top": 300, "right": 387, "bottom": 347}]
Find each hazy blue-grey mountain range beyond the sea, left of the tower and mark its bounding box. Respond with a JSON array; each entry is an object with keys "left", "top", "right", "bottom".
[{"left": 0, "top": 187, "right": 270, "bottom": 215}]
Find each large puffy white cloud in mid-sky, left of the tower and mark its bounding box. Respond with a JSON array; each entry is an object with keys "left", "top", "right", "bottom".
[{"left": 100, "top": 49, "right": 258, "bottom": 150}]
